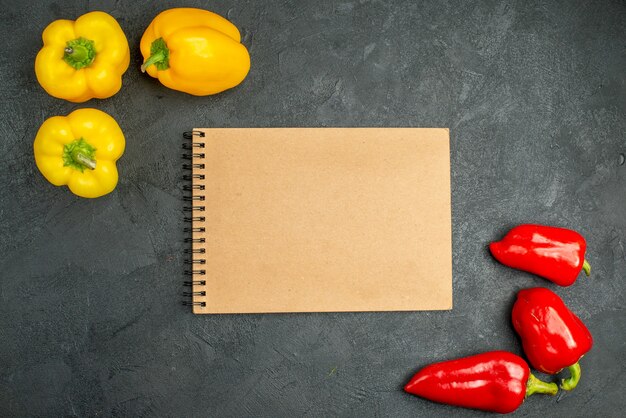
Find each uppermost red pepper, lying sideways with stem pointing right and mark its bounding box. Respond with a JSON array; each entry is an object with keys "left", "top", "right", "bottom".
[{"left": 489, "top": 225, "right": 591, "bottom": 286}]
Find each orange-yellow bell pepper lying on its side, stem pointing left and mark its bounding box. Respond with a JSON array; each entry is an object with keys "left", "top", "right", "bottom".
[{"left": 140, "top": 8, "right": 250, "bottom": 96}]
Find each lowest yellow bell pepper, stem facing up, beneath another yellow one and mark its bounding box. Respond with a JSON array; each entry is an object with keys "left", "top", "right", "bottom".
[{"left": 33, "top": 109, "right": 126, "bottom": 197}]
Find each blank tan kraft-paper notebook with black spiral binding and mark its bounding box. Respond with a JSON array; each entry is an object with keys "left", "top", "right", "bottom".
[{"left": 184, "top": 128, "right": 452, "bottom": 314}]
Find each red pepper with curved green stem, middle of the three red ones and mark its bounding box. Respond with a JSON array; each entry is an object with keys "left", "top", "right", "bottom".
[{"left": 512, "top": 287, "right": 593, "bottom": 390}]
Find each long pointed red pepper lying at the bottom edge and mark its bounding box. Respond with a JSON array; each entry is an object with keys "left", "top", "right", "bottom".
[{"left": 404, "top": 351, "right": 558, "bottom": 414}]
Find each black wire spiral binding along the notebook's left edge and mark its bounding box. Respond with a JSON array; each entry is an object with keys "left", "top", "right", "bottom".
[{"left": 182, "top": 131, "right": 206, "bottom": 306}]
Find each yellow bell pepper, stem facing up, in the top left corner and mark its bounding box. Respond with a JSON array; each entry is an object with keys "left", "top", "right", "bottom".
[{"left": 35, "top": 12, "right": 130, "bottom": 103}]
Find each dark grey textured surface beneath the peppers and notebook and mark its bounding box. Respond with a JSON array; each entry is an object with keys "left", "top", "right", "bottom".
[{"left": 0, "top": 0, "right": 626, "bottom": 417}]
